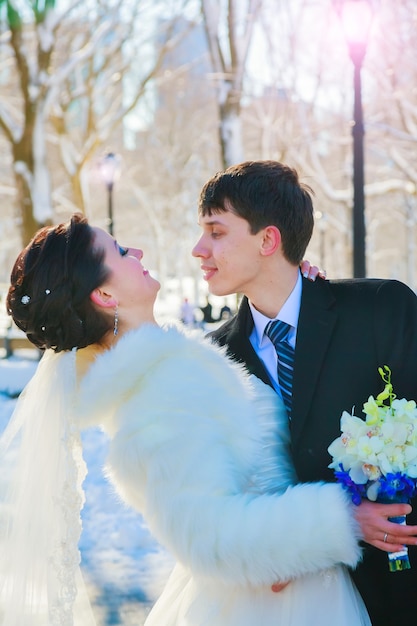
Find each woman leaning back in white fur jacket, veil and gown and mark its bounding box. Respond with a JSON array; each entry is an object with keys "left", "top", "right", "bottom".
[{"left": 0, "top": 215, "right": 370, "bottom": 626}]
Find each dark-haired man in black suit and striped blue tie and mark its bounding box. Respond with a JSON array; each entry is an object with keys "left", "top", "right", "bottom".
[{"left": 193, "top": 161, "right": 417, "bottom": 626}]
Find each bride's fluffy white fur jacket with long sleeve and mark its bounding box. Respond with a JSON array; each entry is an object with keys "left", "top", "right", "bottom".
[{"left": 77, "top": 326, "right": 360, "bottom": 585}]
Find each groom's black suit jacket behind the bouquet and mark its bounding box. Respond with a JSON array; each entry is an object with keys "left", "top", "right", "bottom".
[{"left": 211, "top": 279, "right": 417, "bottom": 626}]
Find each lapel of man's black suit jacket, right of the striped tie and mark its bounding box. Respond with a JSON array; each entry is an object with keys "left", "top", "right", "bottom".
[{"left": 291, "top": 279, "right": 337, "bottom": 443}]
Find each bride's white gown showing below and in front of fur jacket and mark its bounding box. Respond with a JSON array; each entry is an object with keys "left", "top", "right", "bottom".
[{"left": 141, "top": 376, "right": 371, "bottom": 626}]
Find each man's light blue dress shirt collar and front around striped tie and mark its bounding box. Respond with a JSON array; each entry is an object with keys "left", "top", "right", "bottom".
[{"left": 249, "top": 272, "right": 303, "bottom": 395}]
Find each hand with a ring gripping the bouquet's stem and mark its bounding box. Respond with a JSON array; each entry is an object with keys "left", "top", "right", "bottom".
[{"left": 355, "top": 500, "right": 417, "bottom": 552}]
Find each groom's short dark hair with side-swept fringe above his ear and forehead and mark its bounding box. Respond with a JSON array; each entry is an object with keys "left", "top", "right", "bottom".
[{"left": 198, "top": 161, "right": 314, "bottom": 265}]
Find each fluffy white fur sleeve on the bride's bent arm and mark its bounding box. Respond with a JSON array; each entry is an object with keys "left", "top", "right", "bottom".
[{"left": 105, "top": 370, "right": 360, "bottom": 585}]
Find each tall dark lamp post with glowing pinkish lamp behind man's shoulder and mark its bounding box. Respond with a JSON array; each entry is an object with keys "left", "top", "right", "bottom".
[{"left": 338, "top": 0, "right": 373, "bottom": 278}]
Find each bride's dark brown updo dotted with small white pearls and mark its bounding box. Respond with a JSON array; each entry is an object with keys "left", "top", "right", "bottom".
[{"left": 6, "top": 214, "right": 113, "bottom": 352}]
